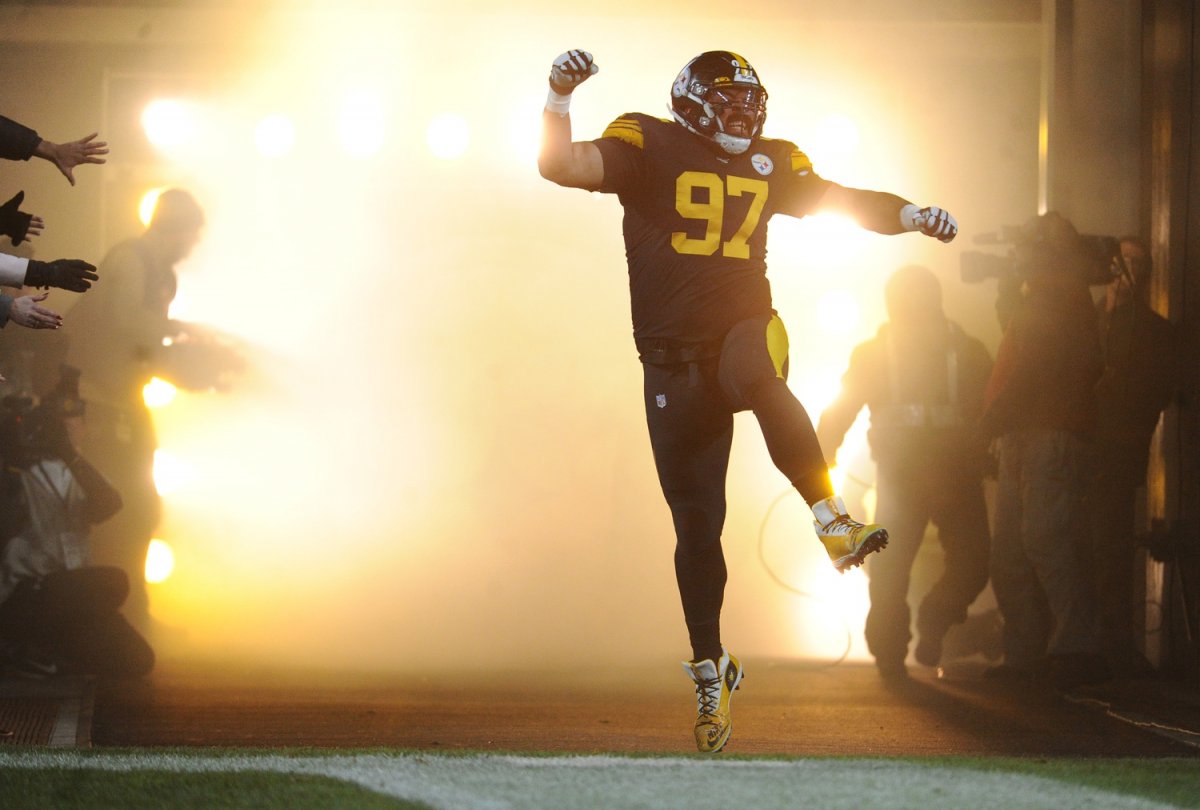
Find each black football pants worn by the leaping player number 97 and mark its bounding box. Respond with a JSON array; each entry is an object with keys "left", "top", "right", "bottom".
[{"left": 643, "top": 316, "right": 833, "bottom": 661}]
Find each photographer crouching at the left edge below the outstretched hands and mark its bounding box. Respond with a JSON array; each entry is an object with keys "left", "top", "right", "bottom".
[{"left": 0, "top": 367, "right": 155, "bottom": 678}]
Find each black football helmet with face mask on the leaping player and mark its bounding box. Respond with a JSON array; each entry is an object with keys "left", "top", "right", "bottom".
[{"left": 671, "top": 50, "right": 767, "bottom": 155}]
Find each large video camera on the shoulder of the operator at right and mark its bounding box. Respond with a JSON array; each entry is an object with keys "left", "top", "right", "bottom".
[{"left": 960, "top": 212, "right": 1124, "bottom": 286}]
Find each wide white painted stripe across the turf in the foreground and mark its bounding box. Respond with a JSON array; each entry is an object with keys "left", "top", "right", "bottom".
[{"left": 0, "top": 749, "right": 1174, "bottom": 810}]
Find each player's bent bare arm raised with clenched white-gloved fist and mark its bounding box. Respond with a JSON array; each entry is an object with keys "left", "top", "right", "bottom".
[{"left": 538, "top": 50, "right": 604, "bottom": 191}]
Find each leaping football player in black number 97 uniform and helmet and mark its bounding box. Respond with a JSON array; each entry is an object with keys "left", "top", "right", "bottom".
[{"left": 538, "top": 50, "right": 958, "bottom": 752}]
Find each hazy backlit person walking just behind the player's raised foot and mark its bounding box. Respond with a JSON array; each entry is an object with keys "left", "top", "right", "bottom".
[{"left": 817, "top": 265, "right": 991, "bottom": 678}]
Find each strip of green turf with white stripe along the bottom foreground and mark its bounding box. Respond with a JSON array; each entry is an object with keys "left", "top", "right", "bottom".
[{"left": 0, "top": 749, "right": 1200, "bottom": 810}]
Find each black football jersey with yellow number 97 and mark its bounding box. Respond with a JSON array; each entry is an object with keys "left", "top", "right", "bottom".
[{"left": 594, "top": 113, "right": 830, "bottom": 343}]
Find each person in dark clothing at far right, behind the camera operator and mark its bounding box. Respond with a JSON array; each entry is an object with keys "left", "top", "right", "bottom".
[{"left": 1088, "top": 236, "right": 1177, "bottom": 674}]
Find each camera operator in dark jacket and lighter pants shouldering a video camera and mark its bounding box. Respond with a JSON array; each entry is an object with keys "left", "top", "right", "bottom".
[{"left": 982, "top": 212, "right": 1108, "bottom": 689}]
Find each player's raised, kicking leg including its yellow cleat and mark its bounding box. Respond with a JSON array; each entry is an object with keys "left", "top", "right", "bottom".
[{"left": 719, "top": 316, "right": 888, "bottom": 571}]
